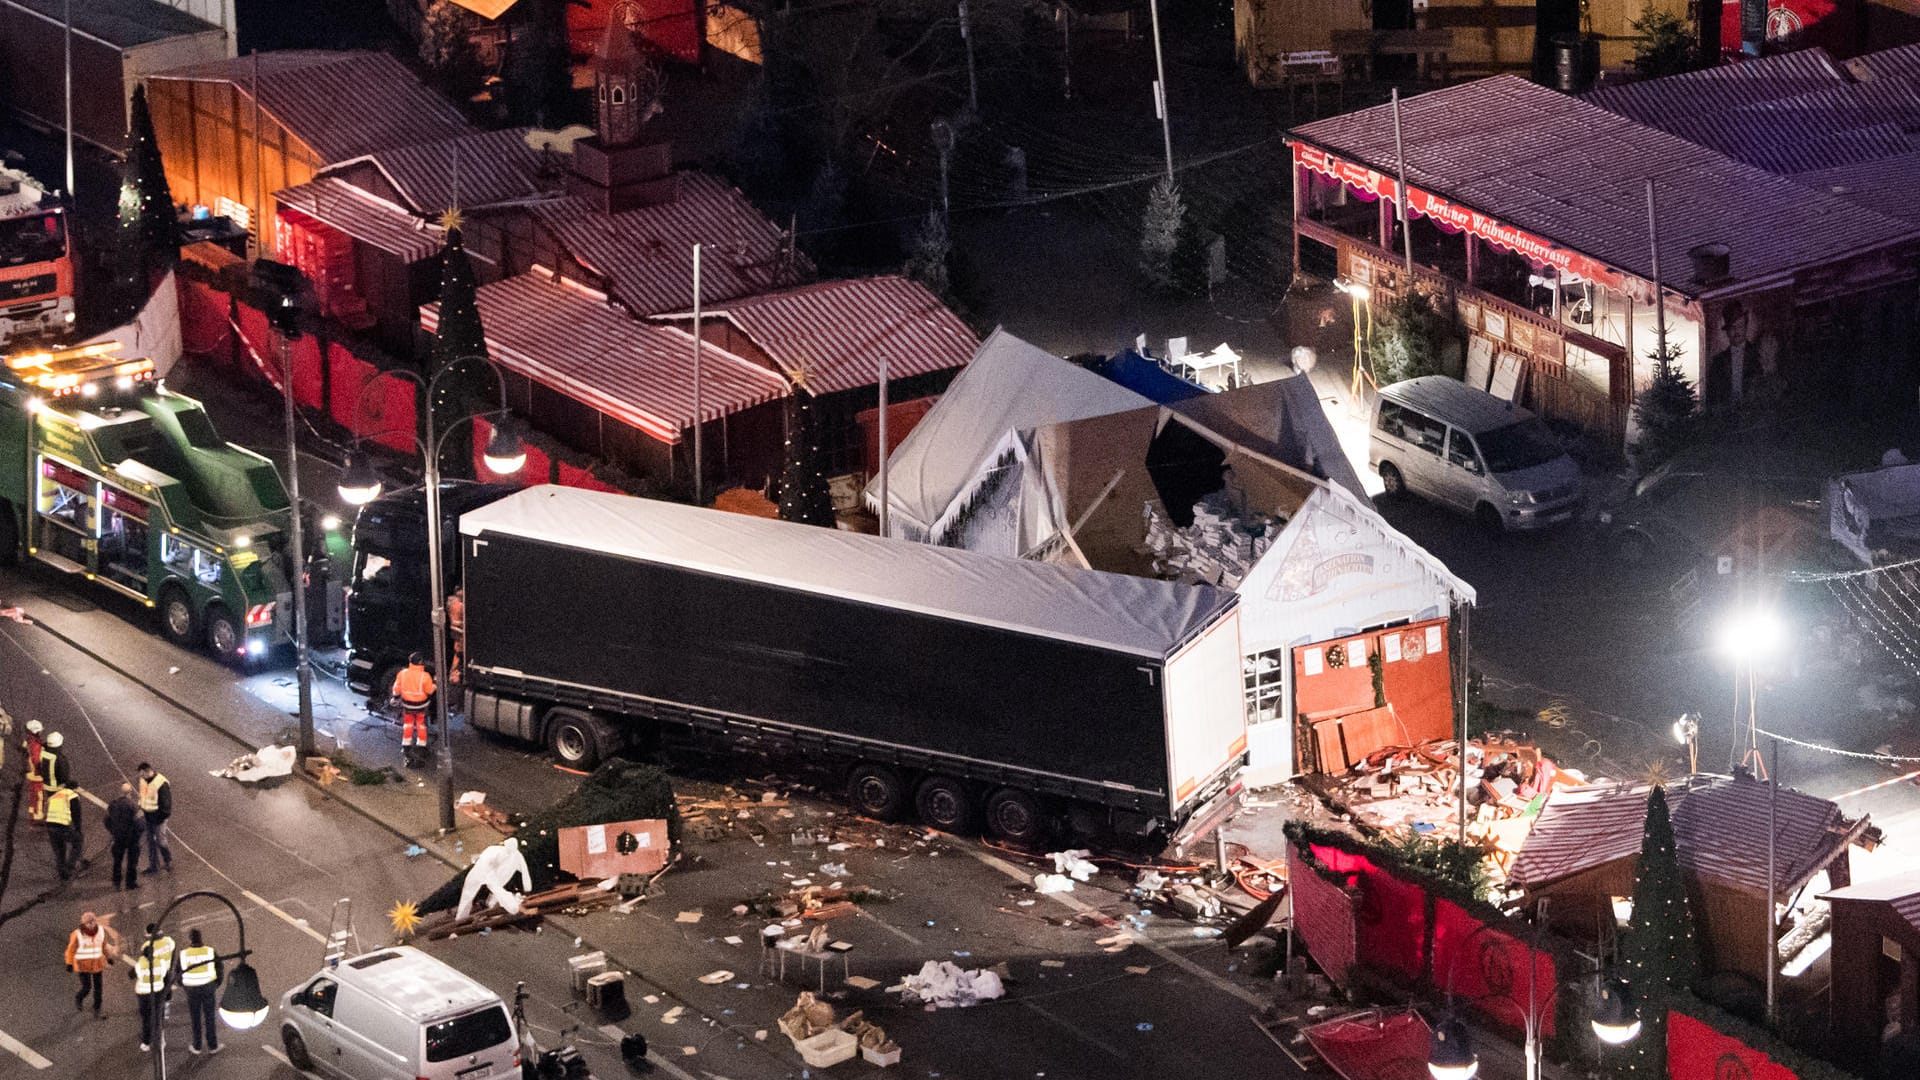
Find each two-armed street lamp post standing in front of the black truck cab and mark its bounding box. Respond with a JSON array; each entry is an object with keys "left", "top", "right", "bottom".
[{"left": 340, "top": 356, "right": 526, "bottom": 832}]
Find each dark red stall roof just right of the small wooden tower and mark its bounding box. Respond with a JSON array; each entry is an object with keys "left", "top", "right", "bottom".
[{"left": 534, "top": 173, "right": 812, "bottom": 315}]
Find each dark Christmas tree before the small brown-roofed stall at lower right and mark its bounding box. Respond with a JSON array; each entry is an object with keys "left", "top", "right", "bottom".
[{"left": 1619, "top": 788, "right": 1699, "bottom": 1080}]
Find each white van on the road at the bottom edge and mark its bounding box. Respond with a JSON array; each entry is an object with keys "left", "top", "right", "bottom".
[{"left": 280, "top": 945, "right": 520, "bottom": 1080}]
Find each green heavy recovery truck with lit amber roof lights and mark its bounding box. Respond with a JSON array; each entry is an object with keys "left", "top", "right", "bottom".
[{"left": 0, "top": 342, "right": 294, "bottom": 663}]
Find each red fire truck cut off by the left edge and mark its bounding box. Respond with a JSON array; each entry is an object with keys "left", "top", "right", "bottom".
[{"left": 0, "top": 165, "right": 73, "bottom": 346}]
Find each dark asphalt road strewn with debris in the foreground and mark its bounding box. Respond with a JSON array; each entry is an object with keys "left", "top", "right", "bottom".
[{"left": 0, "top": 553, "right": 1292, "bottom": 1080}]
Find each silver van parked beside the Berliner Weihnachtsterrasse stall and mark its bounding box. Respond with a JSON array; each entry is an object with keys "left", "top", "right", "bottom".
[{"left": 1367, "top": 375, "right": 1580, "bottom": 528}]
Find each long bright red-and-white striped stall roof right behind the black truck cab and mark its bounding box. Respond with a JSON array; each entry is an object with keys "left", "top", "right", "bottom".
[{"left": 420, "top": 271, "right": 787, "bottom": 442}]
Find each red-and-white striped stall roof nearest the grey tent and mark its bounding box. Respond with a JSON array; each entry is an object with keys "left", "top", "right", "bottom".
[{"left": 668, "top": 275, "right": 979, "bottom": 394}]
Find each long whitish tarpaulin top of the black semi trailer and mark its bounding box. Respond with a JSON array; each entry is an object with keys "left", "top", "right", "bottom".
[{"left": 461, "top": 484, "right": 1236, "bottom": 659}]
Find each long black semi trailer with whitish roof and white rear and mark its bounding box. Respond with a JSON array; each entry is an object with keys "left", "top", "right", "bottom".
[{"left": 459, "top": 486, "right": 1246, "bottom": 849}]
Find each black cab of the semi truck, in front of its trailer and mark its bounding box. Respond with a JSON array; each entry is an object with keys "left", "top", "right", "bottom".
[{"left": 346, "top": 480, "right": 518, "bottom": 701}]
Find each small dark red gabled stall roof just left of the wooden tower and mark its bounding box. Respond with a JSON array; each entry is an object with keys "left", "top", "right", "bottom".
[{"left": 330, "top": 127, "right": 541, "bottom": 213}]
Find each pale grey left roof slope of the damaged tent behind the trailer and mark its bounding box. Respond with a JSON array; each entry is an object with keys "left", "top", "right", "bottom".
[{"left": 866, "top": 329, "right": 1152, "bottom": 534}]
